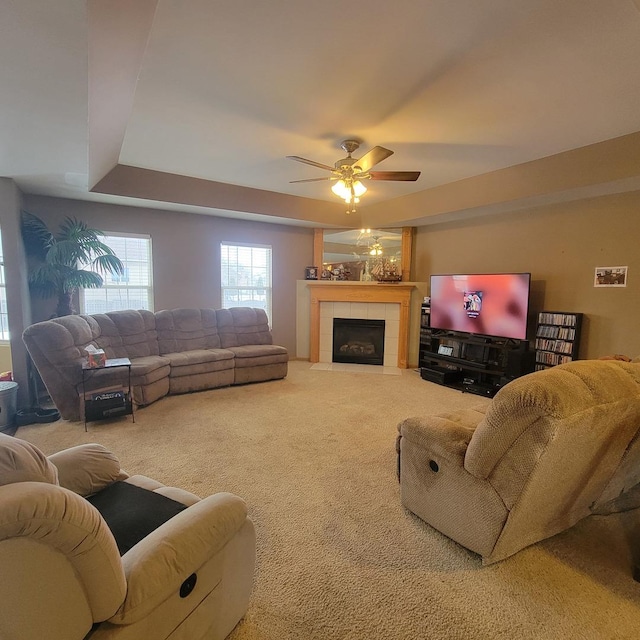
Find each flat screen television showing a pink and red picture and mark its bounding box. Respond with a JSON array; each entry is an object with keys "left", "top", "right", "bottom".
[{"left": 431, "top": 273, "right": 531, "bottom": 340}]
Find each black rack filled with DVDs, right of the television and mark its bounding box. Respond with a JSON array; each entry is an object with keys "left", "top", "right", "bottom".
[{"left": 535, "top": 311, "right": 582, "bottom": 371}]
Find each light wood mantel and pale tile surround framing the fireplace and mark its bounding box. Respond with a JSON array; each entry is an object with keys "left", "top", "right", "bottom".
[{"left": 297, "top": 280, "right": 425, "bottom": 369}]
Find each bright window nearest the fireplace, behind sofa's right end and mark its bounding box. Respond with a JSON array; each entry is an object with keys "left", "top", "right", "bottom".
[{"left": 220, "top": 242, "right": 271, "bottom": 324}]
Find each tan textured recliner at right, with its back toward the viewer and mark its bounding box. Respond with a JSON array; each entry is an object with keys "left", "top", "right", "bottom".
[{"left": 397, "top": 360, "right": 640, "bottom": 564}]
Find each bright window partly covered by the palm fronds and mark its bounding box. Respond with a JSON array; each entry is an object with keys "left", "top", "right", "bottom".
[{"left": 80, "top": 235, "right": 153, "bottom": 313}]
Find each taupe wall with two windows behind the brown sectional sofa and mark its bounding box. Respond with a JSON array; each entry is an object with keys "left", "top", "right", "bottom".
[{"left": 24, "top": 196, "right": 313, "bottom": 354}]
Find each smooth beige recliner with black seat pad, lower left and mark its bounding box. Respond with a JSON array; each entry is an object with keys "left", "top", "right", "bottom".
[{"left": 0, "top": 434, "right": 255, "bottom": 640}]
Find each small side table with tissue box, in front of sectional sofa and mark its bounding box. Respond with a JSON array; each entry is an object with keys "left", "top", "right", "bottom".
[{"left": 82, "top": 358, "right": 136, "bottom": 431}]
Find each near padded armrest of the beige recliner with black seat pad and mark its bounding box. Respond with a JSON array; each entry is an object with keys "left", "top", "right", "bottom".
[{"left": 109, "top": 493, "right": 247, "bottom": 624}]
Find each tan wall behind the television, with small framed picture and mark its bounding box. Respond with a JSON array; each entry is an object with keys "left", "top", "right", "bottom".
[{"left": 413, "top": 192, "right": 640, "bottom": 358}]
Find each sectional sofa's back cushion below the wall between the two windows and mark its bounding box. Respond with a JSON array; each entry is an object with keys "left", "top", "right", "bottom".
[{"left": 156, "top": 309, "right": 220, "bottom": 355}]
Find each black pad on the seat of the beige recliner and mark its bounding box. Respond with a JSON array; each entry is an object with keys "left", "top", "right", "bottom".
[{"left": 87, "top": 482, "right": 187, "bottom": 555}]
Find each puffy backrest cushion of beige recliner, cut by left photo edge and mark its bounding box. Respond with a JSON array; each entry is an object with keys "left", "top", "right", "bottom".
[{"left": 0, "top": 433, "right": 58, "bottom": 485}]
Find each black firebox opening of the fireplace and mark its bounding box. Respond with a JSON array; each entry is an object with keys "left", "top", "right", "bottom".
[{"left": 333, "top": 318, "right": 384, "bottom": 365}]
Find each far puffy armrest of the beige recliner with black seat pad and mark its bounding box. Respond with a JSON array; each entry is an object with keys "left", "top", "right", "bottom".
[{"left": 48, "top": 443, "right": 129, "bottom": 496}]
